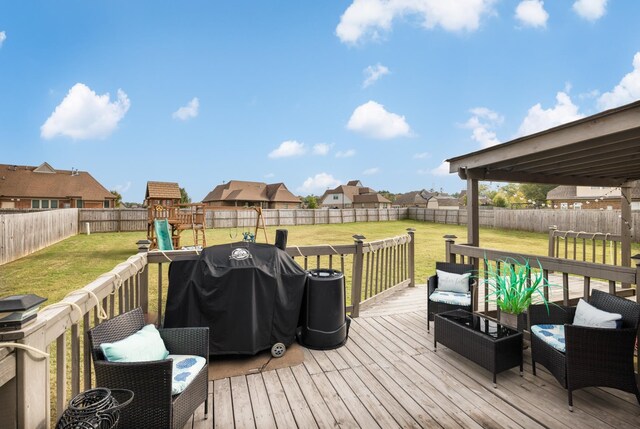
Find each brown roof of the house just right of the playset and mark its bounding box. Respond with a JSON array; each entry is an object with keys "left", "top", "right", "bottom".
[{"left": 202, "top": 180, "right": 300, "bottom": 203}]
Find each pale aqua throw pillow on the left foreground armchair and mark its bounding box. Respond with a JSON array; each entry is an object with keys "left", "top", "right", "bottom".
[{"left": 100, "top": 325, "right": 169, "bottom": 362}]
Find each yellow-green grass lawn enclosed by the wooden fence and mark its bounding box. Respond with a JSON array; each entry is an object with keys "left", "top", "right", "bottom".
[{"left": 0, "top": 220, "right": 576, "bottom": 304}]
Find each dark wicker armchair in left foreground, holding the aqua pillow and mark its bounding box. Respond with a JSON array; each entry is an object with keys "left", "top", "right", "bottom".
[{"left": 88, "top": 308, "right": 209, "bottom": 428}]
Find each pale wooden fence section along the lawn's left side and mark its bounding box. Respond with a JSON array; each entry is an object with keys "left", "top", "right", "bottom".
[{"left": 0, "top": 209, "right": 78, "bottom": 265}]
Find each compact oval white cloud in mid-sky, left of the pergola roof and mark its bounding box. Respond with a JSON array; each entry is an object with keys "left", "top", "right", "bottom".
[{"left": 347, "top": 101, "right": 411, "bottom": 140}]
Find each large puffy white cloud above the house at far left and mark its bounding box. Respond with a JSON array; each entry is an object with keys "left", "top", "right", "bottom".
[{"left": 40, "top": 83, "right": 131, "bottom": 140}]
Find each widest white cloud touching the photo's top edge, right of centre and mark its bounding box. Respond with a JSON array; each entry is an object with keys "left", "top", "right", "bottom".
[{"left": 336, "top": 0, "right": 495, "bottom": 44}]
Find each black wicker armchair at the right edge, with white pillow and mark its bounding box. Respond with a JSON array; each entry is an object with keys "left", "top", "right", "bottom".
[{"left": 529, "top": 290, "right": 640, "bottom": 410}]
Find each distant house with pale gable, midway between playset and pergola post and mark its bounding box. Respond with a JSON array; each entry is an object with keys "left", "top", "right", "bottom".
[{"left": 319, "top": 180, "right": 391, "bottom": 209}]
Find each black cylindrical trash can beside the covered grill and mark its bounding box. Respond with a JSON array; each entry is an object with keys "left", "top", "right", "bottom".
[{"left": 298, "top": 269, "right": 351, "bottom": 350}]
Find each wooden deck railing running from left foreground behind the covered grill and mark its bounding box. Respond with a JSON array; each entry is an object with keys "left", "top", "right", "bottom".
[{"left": 0, "top": 230, "right": 414, "bottom": 428}]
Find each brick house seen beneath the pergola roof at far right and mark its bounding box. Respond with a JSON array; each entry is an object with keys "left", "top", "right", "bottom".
[{"left": 547, "top": 182, "right": 640, "bottom": 210}]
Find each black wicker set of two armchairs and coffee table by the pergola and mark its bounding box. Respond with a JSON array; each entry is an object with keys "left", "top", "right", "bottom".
[{"left": 427, "top": 263, "right": 640, "bottom": 411}]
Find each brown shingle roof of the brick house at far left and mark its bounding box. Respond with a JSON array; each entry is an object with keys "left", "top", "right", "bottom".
[{"left": 0, "top": 162, "right": 116, "bottom": 201}]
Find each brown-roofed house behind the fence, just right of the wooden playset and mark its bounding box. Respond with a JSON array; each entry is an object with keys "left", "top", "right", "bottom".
[{"left": 202, "top": 180, "right": 302, "bottom": 209}]
